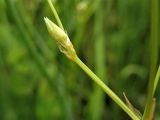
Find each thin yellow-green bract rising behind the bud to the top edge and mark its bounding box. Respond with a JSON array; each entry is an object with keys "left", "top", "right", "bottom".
[{"left": 48, "top": 0, "right": 64, "bottom": 30}]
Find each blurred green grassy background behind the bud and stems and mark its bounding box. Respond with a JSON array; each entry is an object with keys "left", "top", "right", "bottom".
[{"left": 0, "top": 0, "right": 160, "bottom": 120}]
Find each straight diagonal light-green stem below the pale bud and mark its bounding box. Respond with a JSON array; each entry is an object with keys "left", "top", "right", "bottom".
[{"left": 74, "top": 57, "right": 139, "bottom": 120}]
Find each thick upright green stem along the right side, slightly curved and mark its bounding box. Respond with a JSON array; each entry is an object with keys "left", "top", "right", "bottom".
[{"left": 142, "top": 0, "right": 159, "bottom": 120}]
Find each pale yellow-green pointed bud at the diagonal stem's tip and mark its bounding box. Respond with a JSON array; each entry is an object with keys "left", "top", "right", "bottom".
[{"left": 44, "top": 18, "right": 77, "bottom": 60}]
